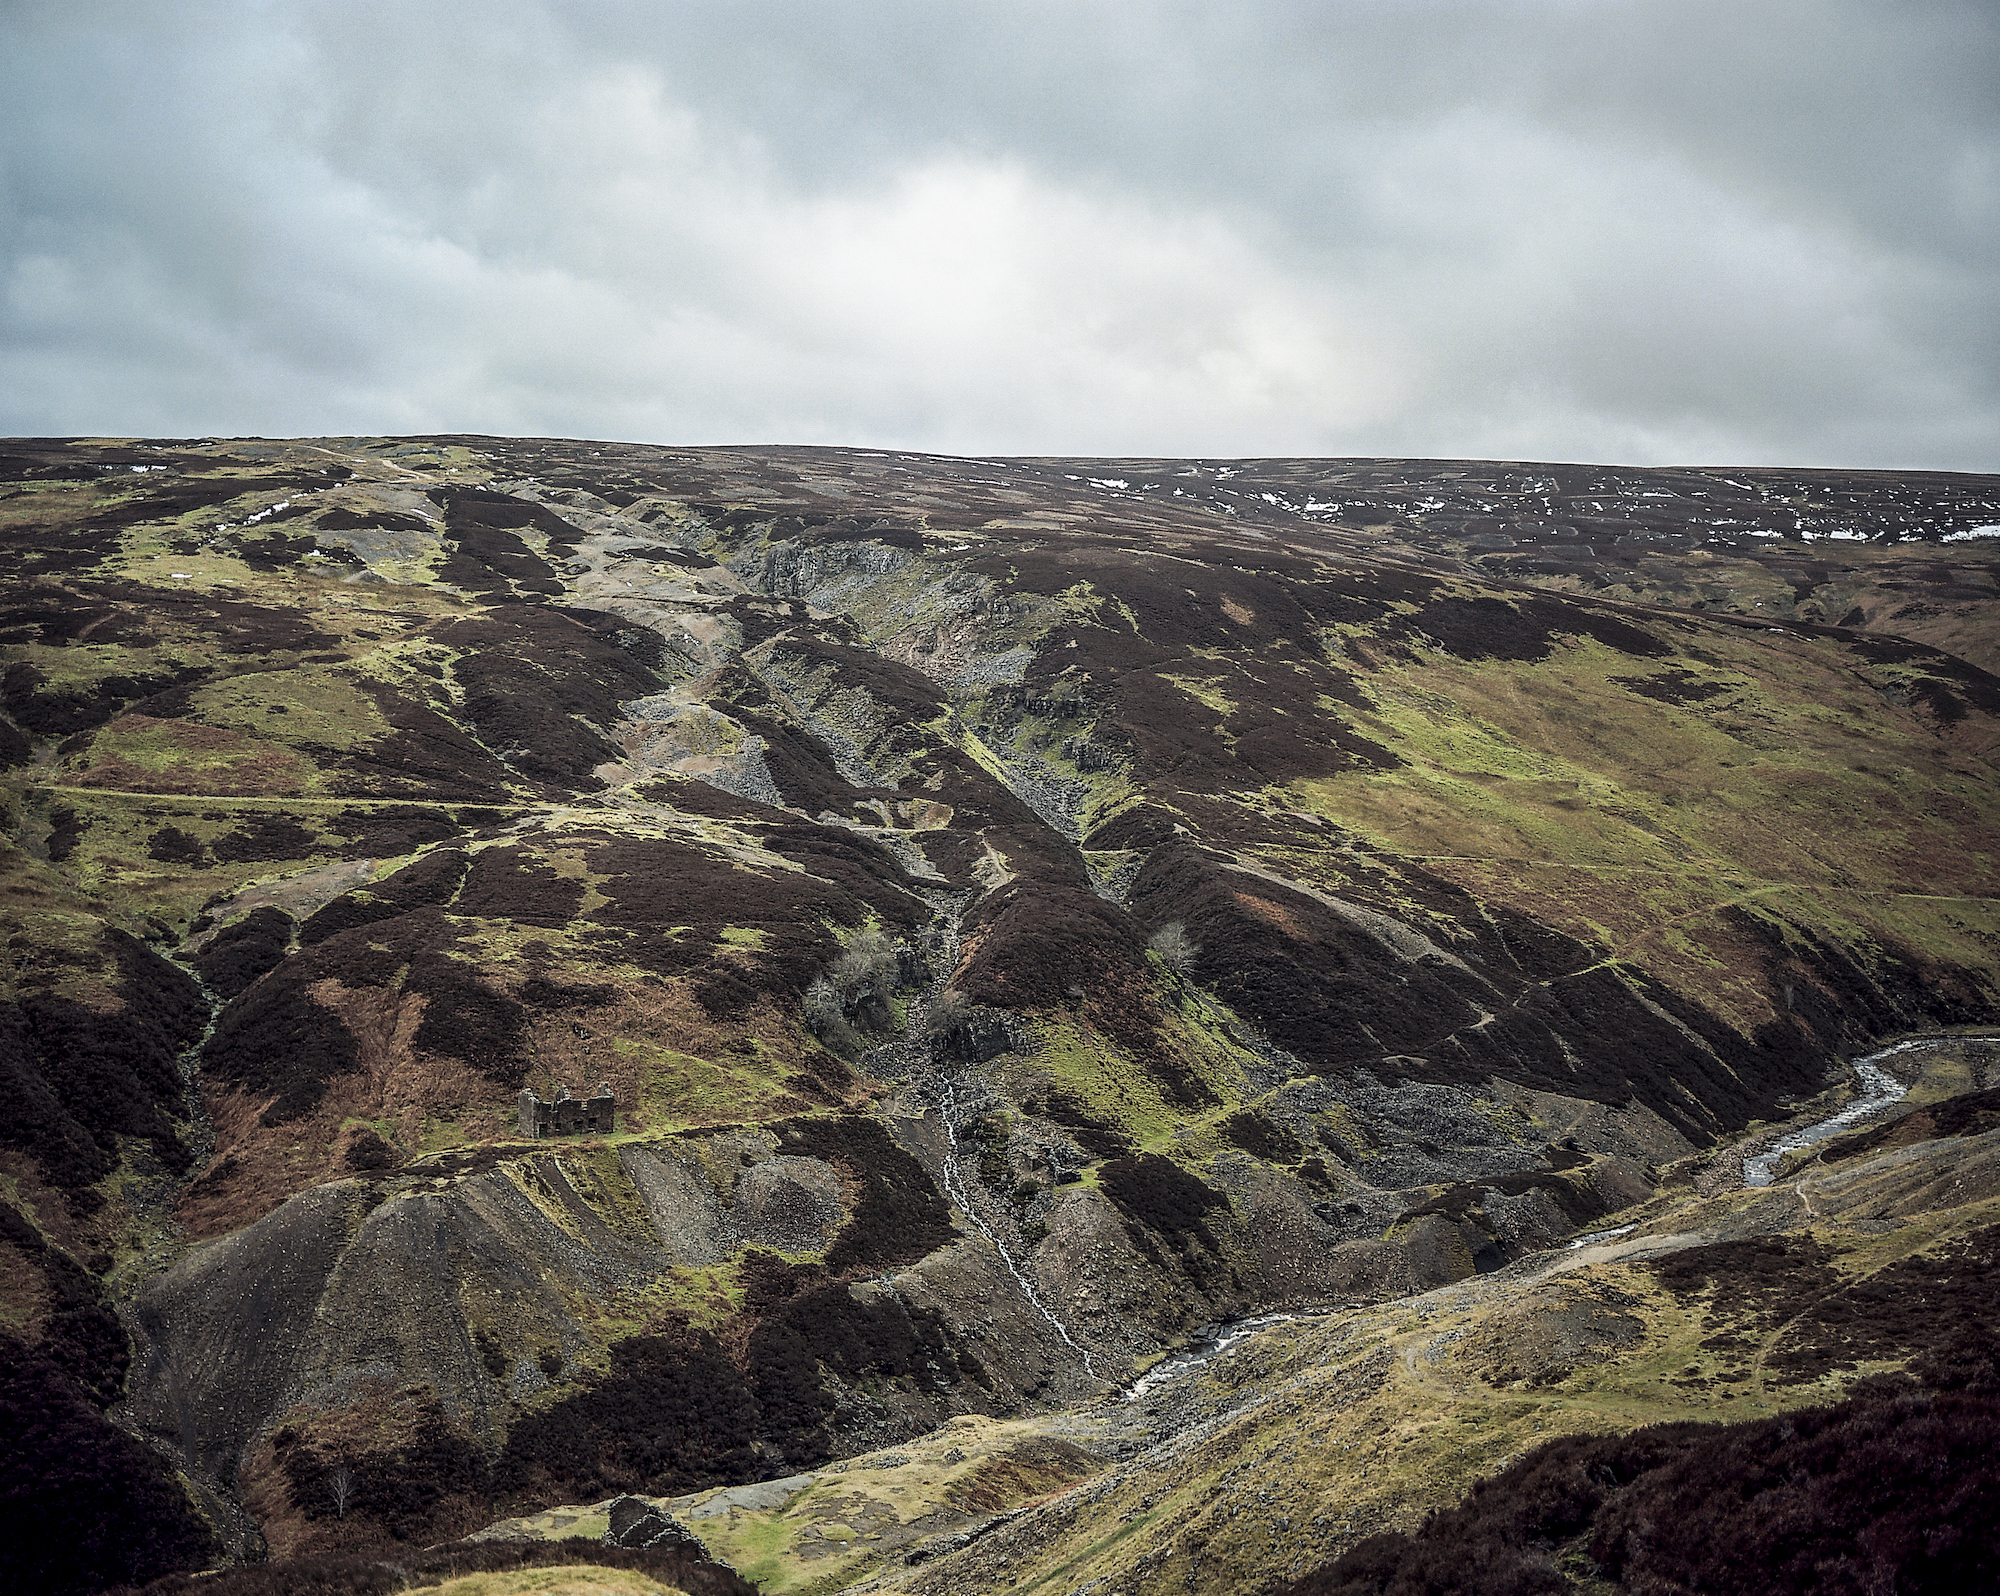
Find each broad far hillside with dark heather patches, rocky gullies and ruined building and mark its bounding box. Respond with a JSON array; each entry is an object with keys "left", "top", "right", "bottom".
[{"left": 0, "top": 438, "right": 2000, "bottom": 1590}]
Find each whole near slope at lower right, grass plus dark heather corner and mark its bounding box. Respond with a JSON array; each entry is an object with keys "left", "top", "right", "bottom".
[{"left": 464, "top": 1044, "right": 2000, "bottom": 1596}]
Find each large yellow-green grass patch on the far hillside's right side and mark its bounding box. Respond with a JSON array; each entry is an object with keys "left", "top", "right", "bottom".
[{"left": 1258, "top": 636, "right": 2000, "bottom": 1026}]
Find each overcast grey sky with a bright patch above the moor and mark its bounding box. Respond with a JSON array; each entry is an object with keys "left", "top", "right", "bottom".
[{"left": 0, "top": 0, "right": 2000, "bottom": 472}]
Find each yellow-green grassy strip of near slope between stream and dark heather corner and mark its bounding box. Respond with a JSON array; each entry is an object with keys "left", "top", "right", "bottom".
[{"left": 464, "top": 1042, "right": 2000, "bottom": 1590}]
